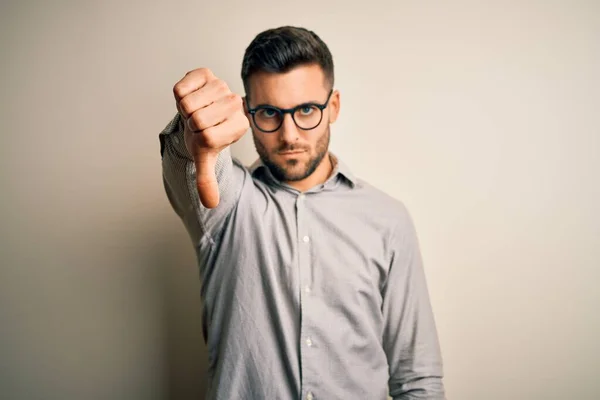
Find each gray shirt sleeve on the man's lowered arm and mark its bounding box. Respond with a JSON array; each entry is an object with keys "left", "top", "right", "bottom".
[{"left": 382, "top": 208, "right": 445, "bottom": 400}]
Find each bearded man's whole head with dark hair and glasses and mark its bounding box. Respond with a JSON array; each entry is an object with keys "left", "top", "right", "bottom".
[{"left": 242, "top": 27, "right": 340, "bottom": 186}]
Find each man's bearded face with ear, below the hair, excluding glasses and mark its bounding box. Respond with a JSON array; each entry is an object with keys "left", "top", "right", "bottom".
[{"left": 246, "top": 65, "right": 339, "bottom": 182}]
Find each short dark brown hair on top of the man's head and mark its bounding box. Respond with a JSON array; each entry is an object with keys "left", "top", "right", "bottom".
[{"left": 242, "top": 26, "right": 334, "bottom": 95}]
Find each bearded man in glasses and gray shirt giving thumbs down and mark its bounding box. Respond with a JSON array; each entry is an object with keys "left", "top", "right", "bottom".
[{"left": 160, "top": 27, "right": 444, "bottom": 400}]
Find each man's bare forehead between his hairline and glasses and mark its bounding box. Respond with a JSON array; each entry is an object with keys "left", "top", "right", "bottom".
[{"left": 249, "top": 64, "right": 329, "bottom": 108}]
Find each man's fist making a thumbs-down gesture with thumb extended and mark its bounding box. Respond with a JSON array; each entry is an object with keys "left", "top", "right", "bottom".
[{"left": 173, "top": 68, "right": 249, "bottom": 208}]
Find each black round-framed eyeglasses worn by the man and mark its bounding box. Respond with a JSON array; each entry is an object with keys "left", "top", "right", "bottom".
[{"left": 248, "top": 89, "right": 333, "bottom": 133}]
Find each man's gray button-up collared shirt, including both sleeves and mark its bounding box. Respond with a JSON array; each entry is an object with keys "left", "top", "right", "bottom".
[{"left": 159, "top": 116, "right": 444, "bottom": 400}]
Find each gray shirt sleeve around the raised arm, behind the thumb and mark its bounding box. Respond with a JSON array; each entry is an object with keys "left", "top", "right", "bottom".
[{"left": 159, "top": 114, "right": 246, "bottom": 245}]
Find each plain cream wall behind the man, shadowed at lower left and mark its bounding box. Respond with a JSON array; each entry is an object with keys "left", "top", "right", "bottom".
[{"left": 0, "top": 0, "right": 600, "bottom": 400}]
